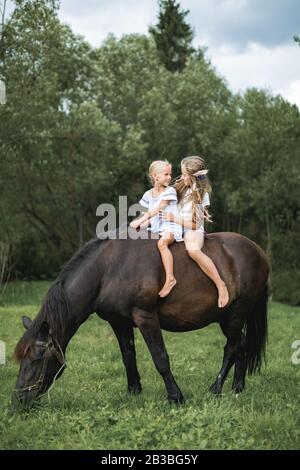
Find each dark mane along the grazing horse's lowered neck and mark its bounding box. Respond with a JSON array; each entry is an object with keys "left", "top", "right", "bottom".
[{"left": 14, "top": 238, "right": 102, "bottom": 361}]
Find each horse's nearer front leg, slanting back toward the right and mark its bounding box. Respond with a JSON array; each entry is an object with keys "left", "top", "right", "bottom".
[{"left": 132, "top": 308, "right": 184, "bottom": 403}]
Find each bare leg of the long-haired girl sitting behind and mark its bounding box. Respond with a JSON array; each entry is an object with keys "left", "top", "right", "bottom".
[{"left": 184, "top": 231, "right": 229, "bottom": 308}]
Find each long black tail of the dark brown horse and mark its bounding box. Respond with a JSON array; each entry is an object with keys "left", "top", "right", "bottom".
[{"left": 245, "top": 284, "right": 269, "bottom": 375}]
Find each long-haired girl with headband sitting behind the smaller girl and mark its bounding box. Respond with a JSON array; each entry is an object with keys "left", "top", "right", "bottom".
[{"left": 161, "top": 156, "right": 229, "bottom": 308}]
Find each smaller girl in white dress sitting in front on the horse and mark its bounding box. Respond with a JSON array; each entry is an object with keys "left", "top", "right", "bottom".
[{"left": 130, "top": 160, "right": 182, "bottom": 297}]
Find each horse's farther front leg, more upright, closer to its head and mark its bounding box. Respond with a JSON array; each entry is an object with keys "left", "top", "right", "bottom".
[{"left": 110, "top": 322, "right": 142, "bottom": 393}]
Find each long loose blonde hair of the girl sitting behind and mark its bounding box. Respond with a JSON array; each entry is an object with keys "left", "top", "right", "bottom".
[{"left": 174, "top": 155, "right": 211, "bottom": 223}]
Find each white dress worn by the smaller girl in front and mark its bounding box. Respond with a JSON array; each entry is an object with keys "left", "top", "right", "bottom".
[{"left": 139, "top": 186, "right": 182, "bottom": 242}]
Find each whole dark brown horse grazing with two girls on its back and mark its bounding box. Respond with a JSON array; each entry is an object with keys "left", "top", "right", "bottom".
[{"left": 14, "top": 232, "right": 269, "bottom": 408}]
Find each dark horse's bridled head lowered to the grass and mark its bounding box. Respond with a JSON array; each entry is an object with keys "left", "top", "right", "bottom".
[{"left": 13, "top": 317, "right": 66, "bottom": 409}]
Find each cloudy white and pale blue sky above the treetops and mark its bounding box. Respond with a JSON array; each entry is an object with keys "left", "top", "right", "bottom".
[{"left": 4, "top": 0, "right": 300, "bottom": 107}]
